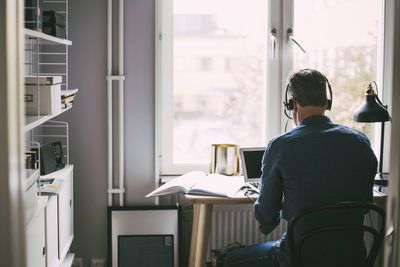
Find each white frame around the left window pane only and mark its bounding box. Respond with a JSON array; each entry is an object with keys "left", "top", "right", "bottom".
[{"left": 155, "top": 0, "right": 282, "bottom": 176}]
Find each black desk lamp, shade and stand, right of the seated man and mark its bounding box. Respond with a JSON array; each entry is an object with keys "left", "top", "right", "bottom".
[{"left": 353, "top": 81, "right": 390, "bottom": 186}]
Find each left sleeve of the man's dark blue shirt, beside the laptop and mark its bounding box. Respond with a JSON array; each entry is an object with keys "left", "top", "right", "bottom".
[{"left": 254, "top": 141, "right": 283, "bottom": 235}]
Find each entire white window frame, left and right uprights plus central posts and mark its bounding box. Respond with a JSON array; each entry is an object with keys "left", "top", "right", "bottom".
[{"left": 155, "top": 0, "right": 394, "bottom": 178}]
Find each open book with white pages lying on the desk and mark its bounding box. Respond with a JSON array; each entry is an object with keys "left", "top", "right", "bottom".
[{"left": 146, "top": 171, "right": 244, "bottom": 197}]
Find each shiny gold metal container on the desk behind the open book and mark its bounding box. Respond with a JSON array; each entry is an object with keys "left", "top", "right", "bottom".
[{"left": 210, "top": 144, "right": 239, "bottom": 176}]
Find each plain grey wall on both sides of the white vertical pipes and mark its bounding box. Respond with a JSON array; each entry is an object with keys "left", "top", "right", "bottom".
[{"left": 64, "top": 0, "right": 154, "bottom": 266}]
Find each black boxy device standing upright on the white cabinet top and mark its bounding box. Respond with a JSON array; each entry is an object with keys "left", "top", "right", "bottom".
[{"left": 40, "top": 141, "right": 65, "bottom": 175}]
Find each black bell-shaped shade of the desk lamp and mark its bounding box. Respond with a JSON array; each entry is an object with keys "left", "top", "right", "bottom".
[{"left": 353, "top": 87, "right": 389, "bottom": 122}]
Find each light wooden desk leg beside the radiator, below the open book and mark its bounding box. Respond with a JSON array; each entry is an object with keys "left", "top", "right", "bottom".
[{"left": 189, "top": 204, "right": 213, "bottom": 267}]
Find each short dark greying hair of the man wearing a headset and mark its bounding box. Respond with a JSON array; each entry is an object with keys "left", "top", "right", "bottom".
[{"left": 288, "top": 69, "right": 327, "bottom": 107}]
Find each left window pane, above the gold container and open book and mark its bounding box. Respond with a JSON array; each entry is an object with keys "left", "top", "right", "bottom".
[{"left": 172, "top": 0, "right": 268, "bottom": 163}]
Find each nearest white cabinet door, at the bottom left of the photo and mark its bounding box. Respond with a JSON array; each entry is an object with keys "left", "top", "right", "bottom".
[{"left": 26, "top": 209, "right": 46, "bottom": 267}]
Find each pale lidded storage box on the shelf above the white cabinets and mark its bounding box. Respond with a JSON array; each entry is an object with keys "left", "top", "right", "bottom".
[{"left": 25, "top": 84, "right": 61, "bottom": 116}]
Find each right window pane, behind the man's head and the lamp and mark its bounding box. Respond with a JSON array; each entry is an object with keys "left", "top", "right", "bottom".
[{"left": 293, "top": 0, "right": 383, "bottom": 141}]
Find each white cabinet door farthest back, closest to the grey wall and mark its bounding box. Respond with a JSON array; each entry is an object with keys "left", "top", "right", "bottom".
[{"left": 58, "top": 172, "right": 74, "bottom": 261}]
